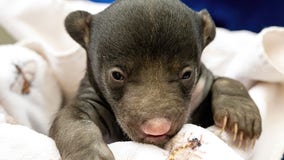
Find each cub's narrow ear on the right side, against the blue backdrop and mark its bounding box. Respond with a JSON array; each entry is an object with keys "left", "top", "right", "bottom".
[{"left": 198, "top": 9, "right": 216, "bottom": 48}]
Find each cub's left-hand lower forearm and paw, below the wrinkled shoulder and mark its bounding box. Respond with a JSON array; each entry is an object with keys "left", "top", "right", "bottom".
[{"left": 50, "top": 108, "right": 114, "bottom": 160}]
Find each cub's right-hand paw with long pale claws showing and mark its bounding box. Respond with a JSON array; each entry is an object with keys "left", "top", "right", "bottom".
[{"left": 211, "top": 77, "right": 262, "bottom": 147}]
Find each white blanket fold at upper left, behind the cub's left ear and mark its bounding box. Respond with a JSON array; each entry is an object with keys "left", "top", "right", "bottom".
[{"left": 0, "top": 0, "right": 109, "bottom": 101}]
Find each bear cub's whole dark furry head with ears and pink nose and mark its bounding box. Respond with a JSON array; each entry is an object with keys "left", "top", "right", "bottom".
[{"left": 65, "top": 0, "right": 215, "bottom": 145}]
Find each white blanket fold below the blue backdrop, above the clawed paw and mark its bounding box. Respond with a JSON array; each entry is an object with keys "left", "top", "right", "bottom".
[{"left": 202, "top": 27, "right": 284, "bottom": 89}]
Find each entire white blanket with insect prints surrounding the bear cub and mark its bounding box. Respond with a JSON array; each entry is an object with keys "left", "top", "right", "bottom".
[{"left": 0, "top": 0, "right": 284, "bottom": 160}]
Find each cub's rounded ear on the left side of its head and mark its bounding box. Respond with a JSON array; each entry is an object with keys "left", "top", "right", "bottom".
[{"left": 65, "top": 11, "right": 92, "bottom": 48}]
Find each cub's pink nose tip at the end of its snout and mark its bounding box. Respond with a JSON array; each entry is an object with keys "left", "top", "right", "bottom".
[{"left": 141, "top": 118, "right": 171, "bottom": 136}]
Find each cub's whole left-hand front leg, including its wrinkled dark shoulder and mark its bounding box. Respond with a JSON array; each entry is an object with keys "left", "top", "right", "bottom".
[{"left": 50, "top": 75, "right": 122, "bottom": 160}]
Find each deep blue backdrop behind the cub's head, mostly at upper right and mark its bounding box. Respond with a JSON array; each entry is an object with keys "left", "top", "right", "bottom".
[{"left": 91, "top": 0, "right": 284, "bottom": 32}]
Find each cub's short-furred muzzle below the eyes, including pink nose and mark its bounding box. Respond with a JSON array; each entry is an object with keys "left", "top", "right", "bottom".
[{"left": 115, "top": 81, "right": 189, "bottom": 146}]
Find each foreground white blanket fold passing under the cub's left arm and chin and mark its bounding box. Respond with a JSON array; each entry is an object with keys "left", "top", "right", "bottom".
[{"left": 0, "top": 123, "right": 243, "bottom": 160}]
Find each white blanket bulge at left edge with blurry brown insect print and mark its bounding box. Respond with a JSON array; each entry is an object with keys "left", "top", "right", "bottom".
[{"left": 0, "top": 45, "right": 62, "bottom": 134}]
